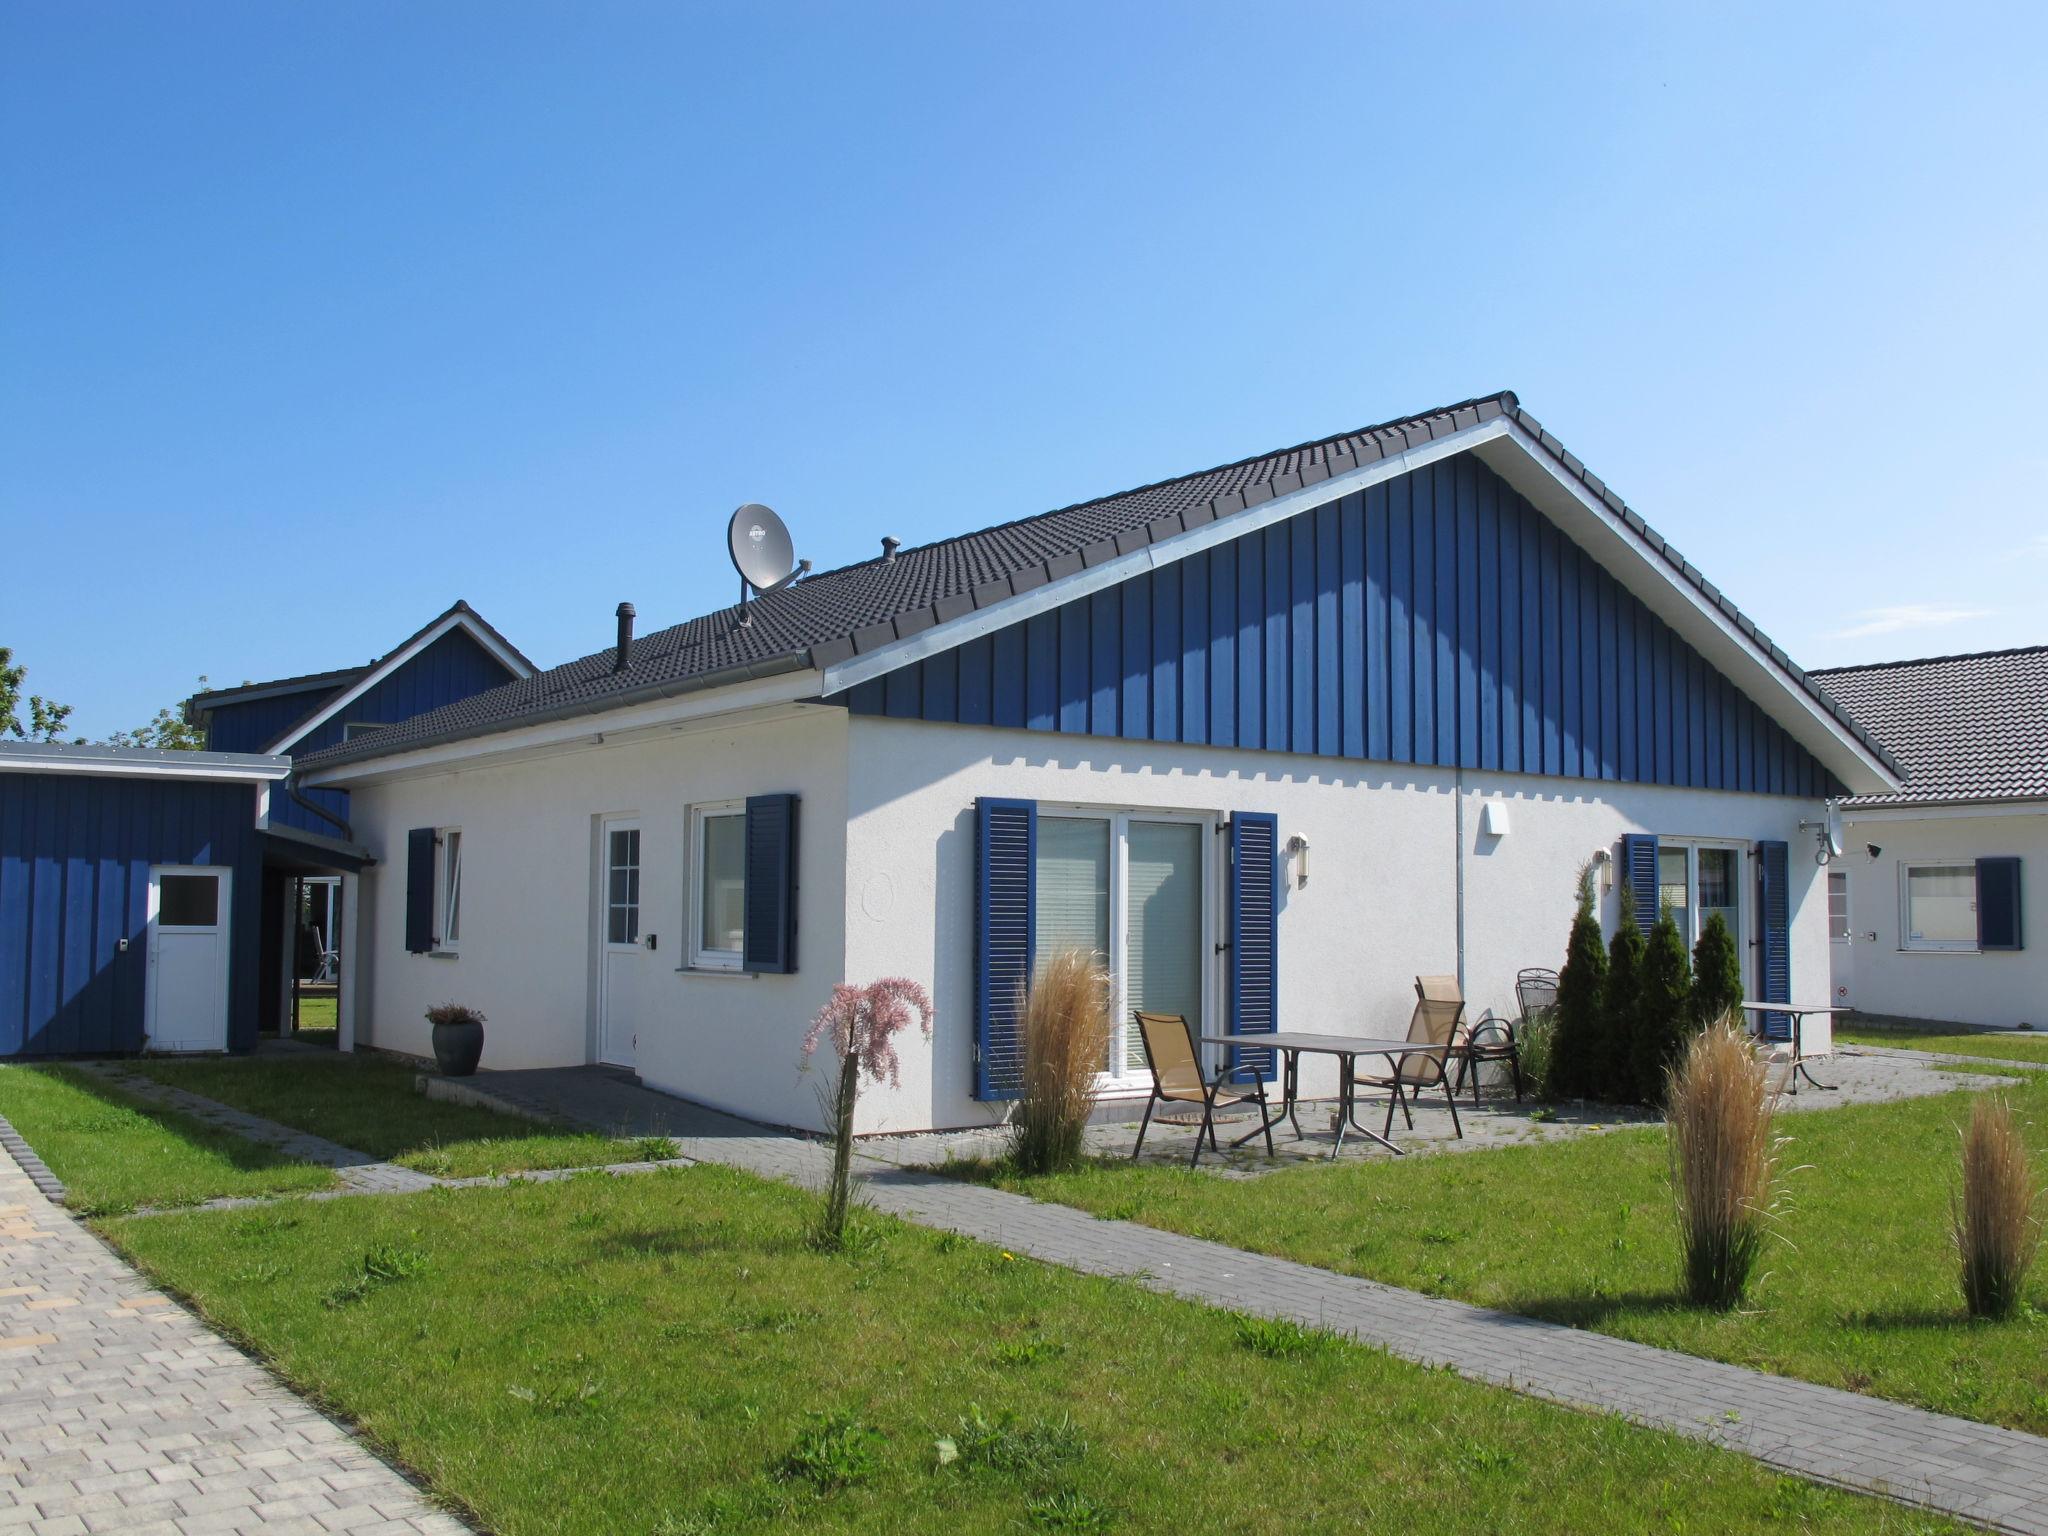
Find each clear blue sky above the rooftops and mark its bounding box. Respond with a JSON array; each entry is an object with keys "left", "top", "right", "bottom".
[{"left": 0, "top": 0, "right": 2048, "bottom": 733}]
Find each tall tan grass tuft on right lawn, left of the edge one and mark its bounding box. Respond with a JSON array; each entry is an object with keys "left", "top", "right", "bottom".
[{"left": 1665, "top": 1024, "right": 1778, "bottom": 1311}]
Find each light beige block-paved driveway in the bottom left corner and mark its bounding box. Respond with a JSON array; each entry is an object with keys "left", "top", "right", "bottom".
[{"left": 0, "top": 1147, "right": 469, "bottom": 1536}]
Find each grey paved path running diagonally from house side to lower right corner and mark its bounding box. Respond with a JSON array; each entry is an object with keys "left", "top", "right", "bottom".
[{"left": 471, "top": 1067, "right": 2048, "bottom": 1536}]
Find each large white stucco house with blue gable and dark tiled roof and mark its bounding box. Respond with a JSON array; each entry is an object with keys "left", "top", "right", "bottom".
[{"left": 297, "top": 393, "right": 1903, "bottom": 1133}]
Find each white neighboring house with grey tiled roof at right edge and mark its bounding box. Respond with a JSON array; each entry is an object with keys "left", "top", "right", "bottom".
[{"left": 1815, "top": 645, "right": 2048, "bottom": 1028}]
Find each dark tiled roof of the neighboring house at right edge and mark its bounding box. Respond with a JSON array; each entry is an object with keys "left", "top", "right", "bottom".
[{"left": 1812, "top": 645, "right": 2048, "bottom": 807}]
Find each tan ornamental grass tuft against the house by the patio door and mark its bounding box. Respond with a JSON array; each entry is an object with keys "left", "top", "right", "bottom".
[{"left": 1010, "top": 948, "right": 1112, "bottom": 1174}]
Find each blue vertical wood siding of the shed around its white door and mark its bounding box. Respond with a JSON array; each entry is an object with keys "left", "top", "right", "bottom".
[{"left": 0, "top": 774, "right": 262, "bottom": 1059}]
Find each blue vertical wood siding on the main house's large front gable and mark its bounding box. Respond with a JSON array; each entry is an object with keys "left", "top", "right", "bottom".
[{"left": 842, "top": 457, "right": 1847, "bottom": 799}]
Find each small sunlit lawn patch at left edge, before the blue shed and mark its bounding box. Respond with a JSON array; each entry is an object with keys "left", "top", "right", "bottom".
[{"left": 0, "top": 1067, "right": 336, "bottom": 1212}]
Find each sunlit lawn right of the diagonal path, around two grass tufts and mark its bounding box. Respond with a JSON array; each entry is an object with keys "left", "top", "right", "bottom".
[{"left": 952, "top": 1077, "right": 2048, "bottom": 1434}]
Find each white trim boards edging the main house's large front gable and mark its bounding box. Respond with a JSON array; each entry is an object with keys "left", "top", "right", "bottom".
[{"left": 823, "top": 416, "right": 1901, "bottom": 795}]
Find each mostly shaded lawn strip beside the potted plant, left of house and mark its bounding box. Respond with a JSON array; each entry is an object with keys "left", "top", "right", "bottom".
[{"left": 125, "top": 1055, "right": 670, "bottom": 1178}]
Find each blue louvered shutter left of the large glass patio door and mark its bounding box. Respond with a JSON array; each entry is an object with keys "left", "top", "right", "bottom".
[{"left": 975, "top": 797, "right": 1038, "bottom": 1100}]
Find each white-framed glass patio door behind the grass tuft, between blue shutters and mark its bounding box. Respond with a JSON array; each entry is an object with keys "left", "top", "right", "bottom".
[{"left": 1032, "top": 811, "right": 1214, "bottom": 1079}]
